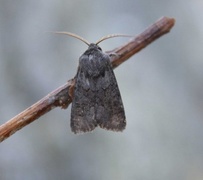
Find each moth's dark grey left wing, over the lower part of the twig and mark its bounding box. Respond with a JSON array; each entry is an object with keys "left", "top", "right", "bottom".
[{"left": 71, "top": 62, "right": 97, "bottom": 134}]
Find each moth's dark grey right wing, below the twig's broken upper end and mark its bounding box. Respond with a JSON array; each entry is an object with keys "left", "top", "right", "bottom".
[{"left": 96, "top": 58, "right": 126, "bottom": 131}]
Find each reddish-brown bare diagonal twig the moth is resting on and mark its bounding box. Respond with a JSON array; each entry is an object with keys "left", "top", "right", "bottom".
[{"left": 0, "top": 17, "right": 175, "bottom": 142}]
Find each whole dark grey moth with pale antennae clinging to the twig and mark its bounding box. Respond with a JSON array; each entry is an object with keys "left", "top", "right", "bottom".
[{"left": 55, "top": 32, "right": 128, "bottom": 134}]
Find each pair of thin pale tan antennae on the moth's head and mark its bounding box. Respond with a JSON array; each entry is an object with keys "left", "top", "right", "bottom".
[{"left": 51, "top": 31, "right": 133, "bottom": 46}]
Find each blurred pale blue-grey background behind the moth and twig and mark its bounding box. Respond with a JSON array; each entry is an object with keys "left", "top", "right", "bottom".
[{"left": 0, "top": 0, "right": 203, "bottom": 180}]
